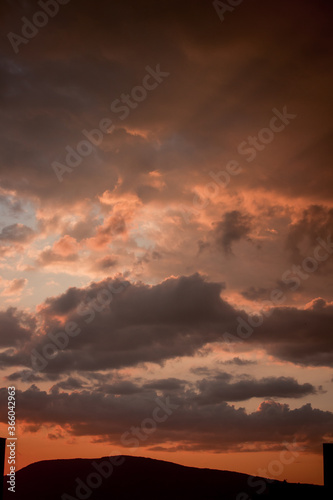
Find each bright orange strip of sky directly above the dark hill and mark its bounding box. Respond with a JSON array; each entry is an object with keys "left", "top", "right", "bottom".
[{"left": 1, "top": 426, "right": 323, "bottom": 484}]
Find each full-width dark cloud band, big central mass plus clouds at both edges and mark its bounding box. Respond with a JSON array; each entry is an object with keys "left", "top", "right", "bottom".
[{"left": 1, "top": 274, "right": 333, "bottom": 373}]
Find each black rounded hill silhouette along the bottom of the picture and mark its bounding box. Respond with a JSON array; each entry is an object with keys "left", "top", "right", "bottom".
[{"left": 4, "top": 456, "right": 326, "bottom": 500}]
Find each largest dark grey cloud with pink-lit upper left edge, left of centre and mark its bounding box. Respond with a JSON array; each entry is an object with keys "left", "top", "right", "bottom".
[{"left": 22, "top": 275, "right": 235, "bottom": 370}]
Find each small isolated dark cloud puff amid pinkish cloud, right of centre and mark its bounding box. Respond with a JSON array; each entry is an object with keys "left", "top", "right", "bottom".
[{"left": 215, "top": 210, "right": 252, "bottom": 254}]
